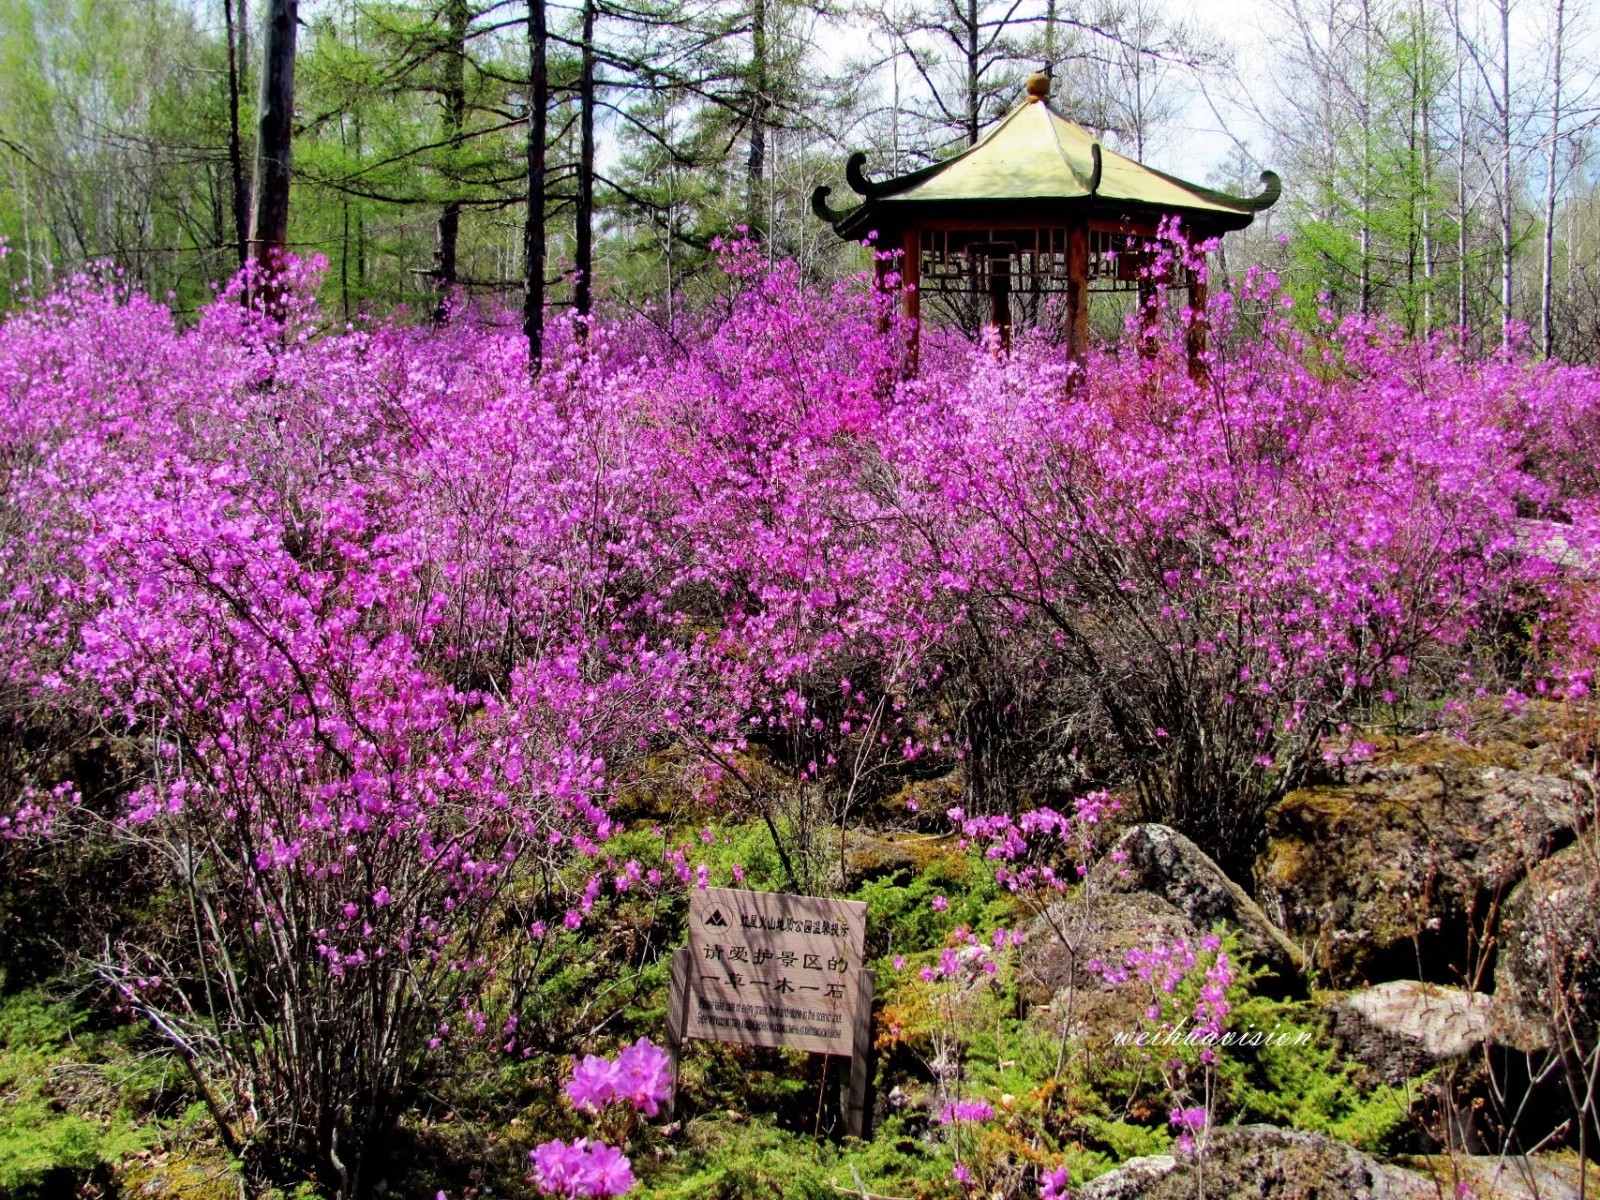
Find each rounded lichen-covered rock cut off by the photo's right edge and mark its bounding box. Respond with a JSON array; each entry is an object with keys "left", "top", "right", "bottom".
[{"left": 1494, "top": 838, "right": 1600, "bottom": 1045}]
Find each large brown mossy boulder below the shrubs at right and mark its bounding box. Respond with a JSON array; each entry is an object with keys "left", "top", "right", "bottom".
[{"left": 1256, "top": 720, "right": 1579, "bottom": 987}]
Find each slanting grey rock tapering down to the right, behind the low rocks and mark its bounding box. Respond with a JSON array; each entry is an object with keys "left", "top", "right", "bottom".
[{"left": 1088, "top": 824, "right": 1304, "bottom": 984}]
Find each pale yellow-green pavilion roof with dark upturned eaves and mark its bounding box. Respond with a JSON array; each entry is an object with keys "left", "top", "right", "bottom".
[{"left": 813, "top": 77, "right": 1280, "bottom": 237}]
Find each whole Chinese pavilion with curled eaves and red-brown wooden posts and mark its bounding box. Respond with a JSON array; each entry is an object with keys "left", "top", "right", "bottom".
[{"left": 811, "top": 75, "right": 1280, "bottom": 371}]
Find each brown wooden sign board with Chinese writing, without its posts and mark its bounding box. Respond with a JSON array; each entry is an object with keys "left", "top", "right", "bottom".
[{"left": 683, "top": 888, "right": 872, "bottom": 1054}]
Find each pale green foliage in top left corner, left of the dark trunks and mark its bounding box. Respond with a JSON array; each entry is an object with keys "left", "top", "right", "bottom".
[{"left": 0, "top": 0, "right": 237, "bottom": 309}]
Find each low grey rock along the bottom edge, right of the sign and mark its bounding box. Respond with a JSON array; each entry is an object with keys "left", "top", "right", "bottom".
[{"left": 1074, "top": 1125, "right": 1438, "bottom": 1200}]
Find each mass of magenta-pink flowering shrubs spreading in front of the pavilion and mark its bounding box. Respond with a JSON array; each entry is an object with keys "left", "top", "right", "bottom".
[{"left": 9, "top": 248, "right": 1600, "bottom": 1195}]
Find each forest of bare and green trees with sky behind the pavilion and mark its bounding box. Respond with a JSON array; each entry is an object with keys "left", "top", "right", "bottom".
[{"left": 9, "top": 0, "right": 1600, "bottom": 362}]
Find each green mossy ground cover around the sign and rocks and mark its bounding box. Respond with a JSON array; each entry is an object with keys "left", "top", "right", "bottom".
[{"left": 0, "top": 822, "right": 1440, "bottom": 1200}]
